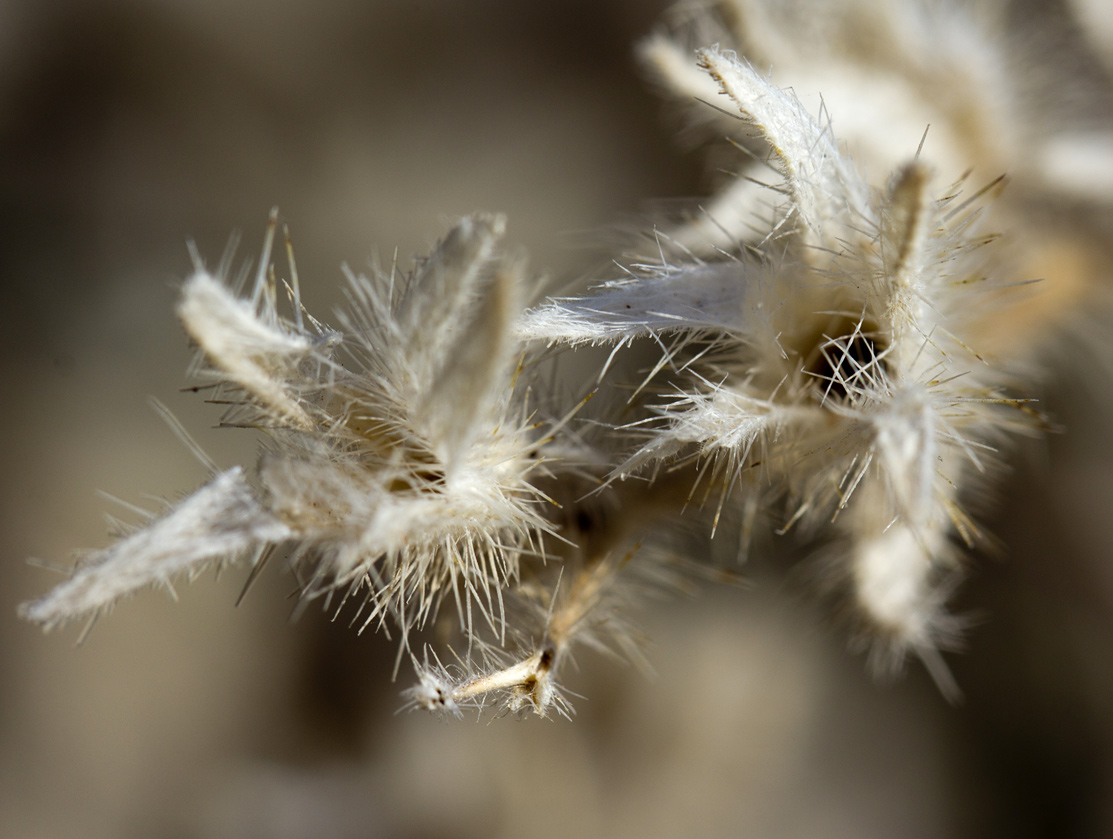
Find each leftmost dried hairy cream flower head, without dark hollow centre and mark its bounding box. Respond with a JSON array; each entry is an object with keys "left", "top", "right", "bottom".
[{"left": 23, "top": 210, "right": 548, "bottom": 640}]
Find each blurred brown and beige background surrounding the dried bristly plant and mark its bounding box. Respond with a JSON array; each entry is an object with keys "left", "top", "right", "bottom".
[{"left": 0, "top": 0, "right": 1113, "bottom": 838}]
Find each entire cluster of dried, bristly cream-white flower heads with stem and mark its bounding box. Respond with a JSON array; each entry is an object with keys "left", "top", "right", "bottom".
[{"left": 22, "top": 0, "right": 1108, "bottom": 715}]
